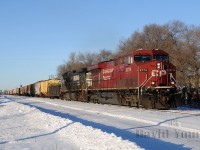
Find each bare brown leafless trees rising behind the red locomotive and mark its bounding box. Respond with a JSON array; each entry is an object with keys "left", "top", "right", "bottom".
[{"left": 57, "top": 20, "right": 200, "bottom": 87}]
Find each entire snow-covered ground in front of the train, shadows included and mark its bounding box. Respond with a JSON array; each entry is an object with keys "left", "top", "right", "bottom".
[{"left": 0, "top": 95, "right": 200, "bottom": 150}]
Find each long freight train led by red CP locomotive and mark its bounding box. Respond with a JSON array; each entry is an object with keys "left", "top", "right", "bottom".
[{"left": 4, "top": 49, "right": 181, "bottom": 109}]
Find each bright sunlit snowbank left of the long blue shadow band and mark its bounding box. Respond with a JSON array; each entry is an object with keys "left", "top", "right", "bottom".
[{"left": 0, "top": 97, "right": 141, "bottom": 150}]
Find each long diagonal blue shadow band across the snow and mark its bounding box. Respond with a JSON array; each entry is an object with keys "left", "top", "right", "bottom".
[{"left": 3, "top": 96, "right": 190, "bottom": 150}]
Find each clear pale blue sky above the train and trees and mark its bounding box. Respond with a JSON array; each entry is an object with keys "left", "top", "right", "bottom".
[{"left": 0, "top": 0, "right": 200, "bottom": 90}]
